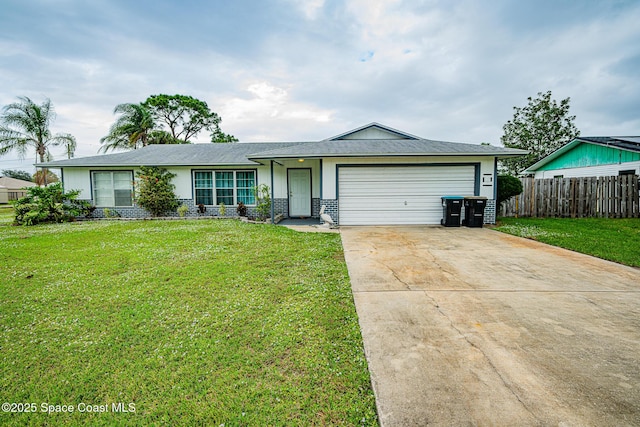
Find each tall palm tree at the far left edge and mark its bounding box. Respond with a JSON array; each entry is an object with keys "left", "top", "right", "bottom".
[{"left": 0, "top": 96, "right": 76, "bottom": 184}]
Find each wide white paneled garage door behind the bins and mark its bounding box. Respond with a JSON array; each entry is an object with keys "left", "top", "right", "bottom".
[{"left": 338, "top": 165, "right": 475, "bottom": 225}]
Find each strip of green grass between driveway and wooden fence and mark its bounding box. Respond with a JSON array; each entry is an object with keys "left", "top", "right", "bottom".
[{"left": 496, "top": 218, "right": 640, "bottom": 267}]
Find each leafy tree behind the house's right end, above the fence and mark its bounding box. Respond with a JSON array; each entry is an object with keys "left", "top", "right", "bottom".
[{"left": 501, "top": 91, "right": 580, "bottom": 175}]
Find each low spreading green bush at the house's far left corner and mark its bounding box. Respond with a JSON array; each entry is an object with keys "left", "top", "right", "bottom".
[{"left": 13, "top": 182, "right": 92, "bottom": 225}]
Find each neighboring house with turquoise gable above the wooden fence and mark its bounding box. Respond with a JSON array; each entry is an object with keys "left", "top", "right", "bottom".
[{"left": 523, "top": 136, "right": 640, "bottom": 178}]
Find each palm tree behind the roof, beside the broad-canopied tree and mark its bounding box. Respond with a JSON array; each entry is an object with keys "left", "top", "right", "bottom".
[{"left": 100, "top": 104, "right": 155, "bottom": 153}]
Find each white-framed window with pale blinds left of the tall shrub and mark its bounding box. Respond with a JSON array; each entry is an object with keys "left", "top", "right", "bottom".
[{"left": 91, "top": 171, "right": 133, "bottom": 207}]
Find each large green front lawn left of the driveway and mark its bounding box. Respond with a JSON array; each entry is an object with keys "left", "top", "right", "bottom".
[{"left": 0, "top": 213, "right": 377, "bottom": 426}]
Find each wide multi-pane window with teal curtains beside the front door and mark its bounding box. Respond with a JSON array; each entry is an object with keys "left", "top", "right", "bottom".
[{"left": 193, "top": 170, "right": 256, "bottom": 206}]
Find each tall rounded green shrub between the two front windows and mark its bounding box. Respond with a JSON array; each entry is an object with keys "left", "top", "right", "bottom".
[{"left": 136, "top": 166, "right": 180, "bottom": 216}]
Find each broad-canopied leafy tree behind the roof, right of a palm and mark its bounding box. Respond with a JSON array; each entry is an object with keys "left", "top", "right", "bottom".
[{"left": 144, "top": 94, "right": 235, "bottom": 142}]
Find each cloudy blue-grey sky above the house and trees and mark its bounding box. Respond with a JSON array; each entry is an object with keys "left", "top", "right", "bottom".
[{"left": 0, "top": 0, "right": 640, "bottom": 171}]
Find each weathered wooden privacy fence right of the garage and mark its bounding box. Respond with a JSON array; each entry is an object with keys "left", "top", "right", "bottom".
[{"left": 501, "top": 175, "right": 640, "bottom": 218}]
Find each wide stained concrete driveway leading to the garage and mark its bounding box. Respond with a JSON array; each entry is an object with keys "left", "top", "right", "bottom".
[{"left": 341, "top": 226, "right": 640, "bottom": 426}]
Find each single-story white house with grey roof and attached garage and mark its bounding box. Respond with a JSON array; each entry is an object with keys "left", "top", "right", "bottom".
[{"left": 38, "top": 123, "right": 526, "bottom": 225}]
